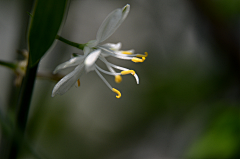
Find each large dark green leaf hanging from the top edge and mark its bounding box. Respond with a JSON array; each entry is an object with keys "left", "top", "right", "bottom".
[{"left": 28, "top": 0, "right": 68, "bottom": 67}]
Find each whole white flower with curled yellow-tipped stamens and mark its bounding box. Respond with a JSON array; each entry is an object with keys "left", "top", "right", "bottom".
[{"left": 52, "top": 4, "right": 147, "bottom": 98}]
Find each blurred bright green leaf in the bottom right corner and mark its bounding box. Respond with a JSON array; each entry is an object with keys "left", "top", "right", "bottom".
[{"left": 187, "top": 108, "right": 240, "bottom": 158}]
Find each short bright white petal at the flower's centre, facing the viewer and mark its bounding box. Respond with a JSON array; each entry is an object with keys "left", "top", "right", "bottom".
[{"left": 84, "top": 49, "right": 101, "bottom": 72}]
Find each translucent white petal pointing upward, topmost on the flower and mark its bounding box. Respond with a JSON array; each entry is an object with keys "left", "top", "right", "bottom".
[{"left": 96, "top": 9, "right": 122, "bottom": 43}]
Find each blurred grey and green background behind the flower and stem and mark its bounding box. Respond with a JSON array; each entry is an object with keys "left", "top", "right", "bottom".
[{"left": 0, "top": 0, "right": 240, "bottom": 159}]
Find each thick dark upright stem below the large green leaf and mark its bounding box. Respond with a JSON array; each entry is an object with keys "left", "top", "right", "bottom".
[{"left": 9, "top": 58, "right": 38, "bottom": 159}]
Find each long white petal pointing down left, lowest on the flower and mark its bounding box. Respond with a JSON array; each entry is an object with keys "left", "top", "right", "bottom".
[{"left": 52, "top": 65, "right": 84, "bottom": 97}]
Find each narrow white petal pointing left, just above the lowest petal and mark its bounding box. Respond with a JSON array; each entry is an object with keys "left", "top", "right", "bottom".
[{"left": 53, "top": 56, "right": 85, "bottom": 74}]
